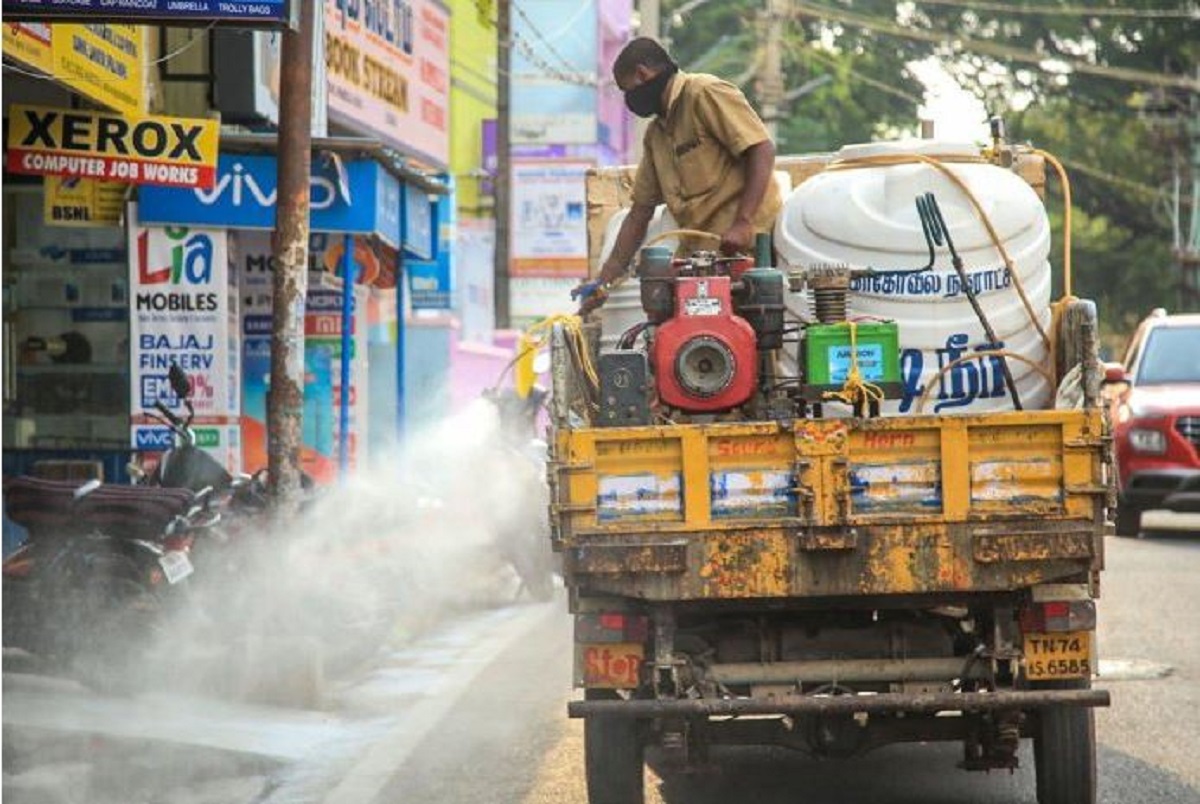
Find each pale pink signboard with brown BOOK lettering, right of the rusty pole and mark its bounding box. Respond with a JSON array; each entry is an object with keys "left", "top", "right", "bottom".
[{"left": 325, "top": 0, "right": 450, "bottom": 168}]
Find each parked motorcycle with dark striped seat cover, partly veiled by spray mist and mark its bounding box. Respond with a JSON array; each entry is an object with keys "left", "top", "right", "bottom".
[{"left": 4, "top": 476, "right": 204, "bottom": 691}]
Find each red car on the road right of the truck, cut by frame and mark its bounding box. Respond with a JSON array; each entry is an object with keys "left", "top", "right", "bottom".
[{"left": 1105, "top": 310, "right": 1200, "bottom": 536}]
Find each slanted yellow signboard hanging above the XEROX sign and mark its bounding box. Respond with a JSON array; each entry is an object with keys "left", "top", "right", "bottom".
[{"left": 4, "top": 23, "right": 146, "bottom": 115}]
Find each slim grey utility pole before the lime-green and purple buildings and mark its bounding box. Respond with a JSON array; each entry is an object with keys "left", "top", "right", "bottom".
[{"left": 492, "top": 0, "right": 512, "bottom": 329}]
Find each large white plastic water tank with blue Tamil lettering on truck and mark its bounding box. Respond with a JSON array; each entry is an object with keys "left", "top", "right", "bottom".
[{"left": 775, "top": 140, "right": 1054, "bottom": 413}]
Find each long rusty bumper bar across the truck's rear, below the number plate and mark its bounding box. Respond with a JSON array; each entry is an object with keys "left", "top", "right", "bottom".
[{"left": 566, "top": 690, "right": 1110, "bottom": 720}]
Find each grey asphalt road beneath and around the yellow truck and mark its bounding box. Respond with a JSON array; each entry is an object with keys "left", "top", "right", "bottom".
[{"left": 4, "top": 535, "right": 1200, "bottom": 804}]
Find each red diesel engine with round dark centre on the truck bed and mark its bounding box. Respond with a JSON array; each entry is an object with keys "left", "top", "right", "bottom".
[{"left": 652, "top": 276, "right": 758, "bottom": 413}]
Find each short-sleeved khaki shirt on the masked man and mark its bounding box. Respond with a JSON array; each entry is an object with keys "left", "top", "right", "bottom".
[{"left": 632, "top": 72, "right": 782, "bottom": 250}]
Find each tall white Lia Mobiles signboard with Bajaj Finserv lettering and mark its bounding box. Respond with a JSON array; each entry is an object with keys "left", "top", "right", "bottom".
[{"left": 128, "top": 204, "right": 240, "bottom": 466}]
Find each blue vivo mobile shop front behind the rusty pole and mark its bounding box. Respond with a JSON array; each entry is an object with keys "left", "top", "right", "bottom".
[{"left": 134, "top": 140, "right": 412, "bottom": 481}]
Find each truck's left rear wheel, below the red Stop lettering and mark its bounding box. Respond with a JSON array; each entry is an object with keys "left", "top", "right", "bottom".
[{"left": 583, "top": 690, "right": 646, "bottom": 804}]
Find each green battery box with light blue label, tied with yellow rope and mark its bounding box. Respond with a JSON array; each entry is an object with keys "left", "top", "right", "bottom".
[{"left": 804, "top": 322, "right": 900, "bottom": 396}]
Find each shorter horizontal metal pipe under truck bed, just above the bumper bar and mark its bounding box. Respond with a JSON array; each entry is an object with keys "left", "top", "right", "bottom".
[{"left": 706, "top": 656, "right": 988, "bottom": 684}]
